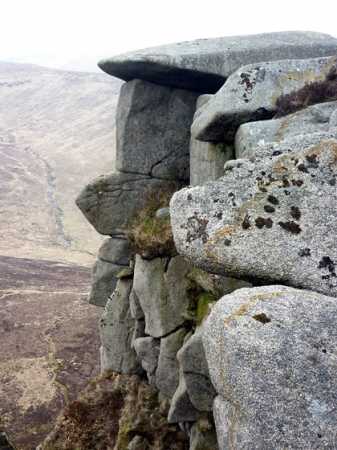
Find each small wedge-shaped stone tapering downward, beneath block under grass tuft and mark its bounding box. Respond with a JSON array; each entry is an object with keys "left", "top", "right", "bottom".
[{"left": 133, "top": 336, "right": 160, "bottom": 384}]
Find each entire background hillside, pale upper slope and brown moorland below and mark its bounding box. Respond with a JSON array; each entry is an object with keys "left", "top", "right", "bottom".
[{"left": 0, "top": 63, "right": 121, "bottom": 450}]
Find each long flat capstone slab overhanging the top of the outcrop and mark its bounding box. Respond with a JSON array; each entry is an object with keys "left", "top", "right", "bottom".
[{"left": 98, "top": 31, "right": 337, "bottom": 93}]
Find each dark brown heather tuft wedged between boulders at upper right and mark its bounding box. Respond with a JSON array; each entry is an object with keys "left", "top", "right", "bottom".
[{"left": 275, "top": 66, "right": 337, "bottom": 117}]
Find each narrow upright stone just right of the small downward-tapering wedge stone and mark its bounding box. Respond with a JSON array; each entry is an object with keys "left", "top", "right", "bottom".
[{"left": 156, "top": 328, "right": 186, "bottom": 398}]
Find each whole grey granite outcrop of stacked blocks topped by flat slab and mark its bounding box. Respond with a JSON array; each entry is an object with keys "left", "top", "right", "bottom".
[{"left": 67, "top": 32, "right": 337, "bottom": 450}]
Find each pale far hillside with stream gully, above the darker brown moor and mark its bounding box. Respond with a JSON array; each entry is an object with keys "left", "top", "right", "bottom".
[{"left": 0, "top": 63, "right": 121, "bottom": 265}]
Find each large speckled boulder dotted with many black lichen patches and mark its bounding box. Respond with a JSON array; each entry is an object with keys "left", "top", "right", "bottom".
[{"left": 171, "top": 139, "right": 337, "bottom": 296}]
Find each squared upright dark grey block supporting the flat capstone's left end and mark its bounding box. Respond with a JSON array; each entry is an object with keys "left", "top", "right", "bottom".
[{"left": 116, "top": 80, "right": 198, "bottom": 182}]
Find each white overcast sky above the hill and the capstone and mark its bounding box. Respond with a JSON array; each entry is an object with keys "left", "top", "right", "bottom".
[{"left": 0, "top": 0, "right": 337, "bottom": 70}]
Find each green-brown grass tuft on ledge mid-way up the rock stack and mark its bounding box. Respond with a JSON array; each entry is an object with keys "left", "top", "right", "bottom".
[{"left": 127, "top": 184, "right": 177, "bottom": 259}]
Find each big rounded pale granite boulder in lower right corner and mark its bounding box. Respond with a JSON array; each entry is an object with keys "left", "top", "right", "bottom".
[{"left": 203, "top": 286, "right": 337, "bottom": 450}]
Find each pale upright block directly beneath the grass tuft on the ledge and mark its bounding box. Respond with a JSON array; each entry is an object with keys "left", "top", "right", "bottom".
[{"left": 133, "top": 255, "right": 191, "bottom": 337}]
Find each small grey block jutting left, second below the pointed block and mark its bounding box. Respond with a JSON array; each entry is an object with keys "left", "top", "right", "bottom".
[{"left": 89, "top": 259, "right": 126, "bottom": 306}]
